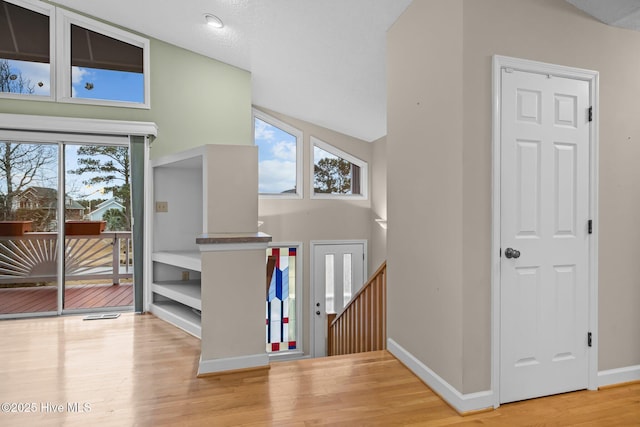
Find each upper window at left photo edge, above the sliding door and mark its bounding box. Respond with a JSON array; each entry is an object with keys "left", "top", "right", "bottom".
[{"left": 0, "top": 0, "right": 54, "bottom": 98}]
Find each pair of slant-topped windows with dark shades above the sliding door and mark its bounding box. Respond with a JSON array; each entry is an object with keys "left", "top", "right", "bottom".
[{"left": 0, "top": 0, "right": 150, "bottom": 108}]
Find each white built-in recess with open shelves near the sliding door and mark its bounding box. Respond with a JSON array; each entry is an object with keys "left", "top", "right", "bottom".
[{"left": 148, "top": 147, "right": 206, "bottom": 338}]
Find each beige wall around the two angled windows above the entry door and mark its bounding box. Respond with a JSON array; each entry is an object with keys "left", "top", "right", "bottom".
[{"left": 258, "top": 108, "right": 379, "bottom": 353}]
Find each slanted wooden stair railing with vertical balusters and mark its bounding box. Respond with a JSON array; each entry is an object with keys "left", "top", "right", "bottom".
[{"left": 327, "top": 262, "right": 387, "bottom": 356}]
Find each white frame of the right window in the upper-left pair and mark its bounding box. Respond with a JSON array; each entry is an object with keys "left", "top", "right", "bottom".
[{"left": 55, "top": 8, "right": 151, "bottom": 109}]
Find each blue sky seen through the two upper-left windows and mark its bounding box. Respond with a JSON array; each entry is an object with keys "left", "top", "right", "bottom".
[{"left": 4, "top": 60, "right": 144, "bottom": 103}]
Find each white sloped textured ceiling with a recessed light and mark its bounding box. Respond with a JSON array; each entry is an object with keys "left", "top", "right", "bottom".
[{"left": 48, "top": 0, "right": 411, "bottom": 141}]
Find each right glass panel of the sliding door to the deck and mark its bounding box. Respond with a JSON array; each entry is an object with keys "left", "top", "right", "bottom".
[{"left": 64, "top": 144, "right": 133, "bottom": 311}]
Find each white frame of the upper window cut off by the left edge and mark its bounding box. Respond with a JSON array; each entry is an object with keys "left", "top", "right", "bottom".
[{"left": 0, "top": 0, "right": 57, "bottom": 102}]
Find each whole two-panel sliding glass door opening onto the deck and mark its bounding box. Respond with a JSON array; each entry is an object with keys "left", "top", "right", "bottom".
[{"left": 0, "top": 141, "right": 134, "bottom": 317}]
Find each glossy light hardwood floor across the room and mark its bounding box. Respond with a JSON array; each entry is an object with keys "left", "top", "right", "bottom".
[{"left": 0, "top": 314, "right": 640, "bottom": 426}]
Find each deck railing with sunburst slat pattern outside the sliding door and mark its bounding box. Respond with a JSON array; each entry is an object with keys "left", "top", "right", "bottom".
[{"left": 0, "top": 231, "right": 133, "bottom": 284}]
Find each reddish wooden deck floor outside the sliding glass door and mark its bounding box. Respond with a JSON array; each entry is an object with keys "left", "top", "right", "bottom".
[{"left": 0, "top": 284, "right": 133, "bottom": 314}]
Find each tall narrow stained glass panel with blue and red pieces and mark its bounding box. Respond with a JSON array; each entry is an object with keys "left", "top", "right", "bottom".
[{"left": 266, "top": 247, "right": 297, "bottom": 353}]
